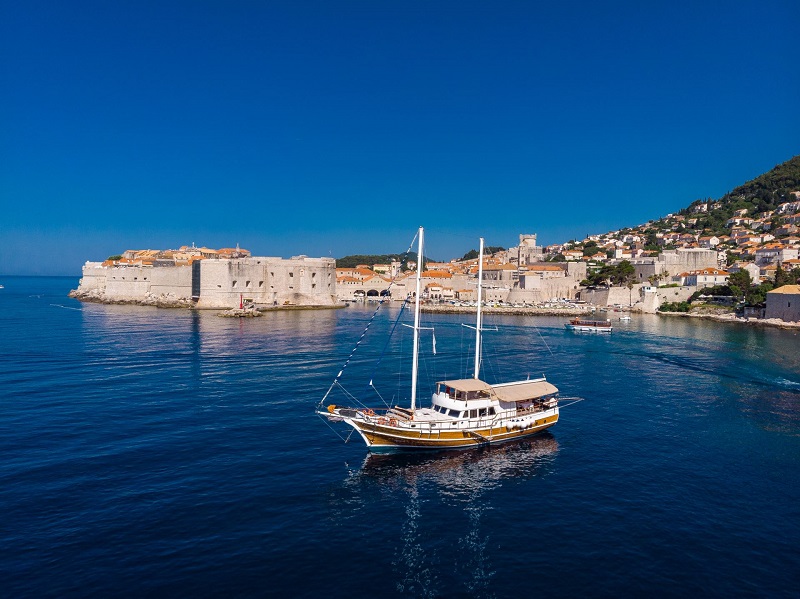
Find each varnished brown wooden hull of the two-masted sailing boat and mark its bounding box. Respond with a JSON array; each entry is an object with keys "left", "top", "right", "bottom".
[{"left": 347, "top": 412, "right": 558, "bottom": 451}]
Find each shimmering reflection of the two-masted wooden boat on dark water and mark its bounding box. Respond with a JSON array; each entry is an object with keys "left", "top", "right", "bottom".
[{"left": 334, "top": 433, "right": 558, "bottom": 597}]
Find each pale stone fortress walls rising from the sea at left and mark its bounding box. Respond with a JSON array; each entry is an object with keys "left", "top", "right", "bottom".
[{"left": 70, "top": 256, "right": 338, "bottom": 309}]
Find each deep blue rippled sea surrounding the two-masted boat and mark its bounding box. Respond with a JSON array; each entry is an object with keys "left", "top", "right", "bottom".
[{"left": 0, "top": 277, "right": 800, "bottom": 598}]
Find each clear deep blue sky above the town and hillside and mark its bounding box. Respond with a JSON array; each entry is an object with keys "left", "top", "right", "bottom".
[{"left": 0, "top": 0, "right": 800, "bottom": 276}]
